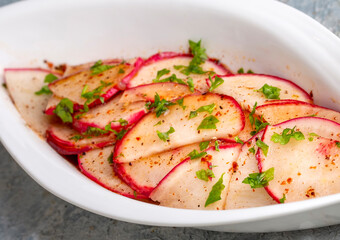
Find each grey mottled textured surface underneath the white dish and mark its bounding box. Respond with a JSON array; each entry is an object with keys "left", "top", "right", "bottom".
[{"left": 0, "top": 0, "right": 340, "bottom": 240}]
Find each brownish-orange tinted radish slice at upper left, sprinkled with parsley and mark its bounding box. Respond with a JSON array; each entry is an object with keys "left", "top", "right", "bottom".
[{"left": 49, "top": 59, "right": 143, "bottom": 108}]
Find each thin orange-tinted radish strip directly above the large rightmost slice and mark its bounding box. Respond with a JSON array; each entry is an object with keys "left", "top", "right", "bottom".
[{"left": 256, "top": 101, "right": 340, "bottom": 125}]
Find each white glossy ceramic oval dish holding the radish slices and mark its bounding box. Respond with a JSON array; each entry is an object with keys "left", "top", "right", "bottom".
[{"left": 0, "top": 0, "right": 340, "bottom": 232}]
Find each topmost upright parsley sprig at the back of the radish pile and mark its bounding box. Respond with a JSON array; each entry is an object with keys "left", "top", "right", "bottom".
[{"left": 174, "top": 40, "right": 208, "bottom": 76}]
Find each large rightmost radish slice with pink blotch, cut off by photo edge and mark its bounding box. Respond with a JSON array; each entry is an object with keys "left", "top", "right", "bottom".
[{"left": 256, "top": 117, "right": 340, "bottom": 203}]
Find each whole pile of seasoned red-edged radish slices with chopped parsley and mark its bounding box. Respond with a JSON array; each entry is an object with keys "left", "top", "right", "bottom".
[{"left": 5, "top": 41, "right": 340, "bottom": 210}]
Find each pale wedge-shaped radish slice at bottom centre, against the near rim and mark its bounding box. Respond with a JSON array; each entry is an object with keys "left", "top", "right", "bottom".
[{"left": 150, "top": 143, "right": 241, "bottom": 210}]
